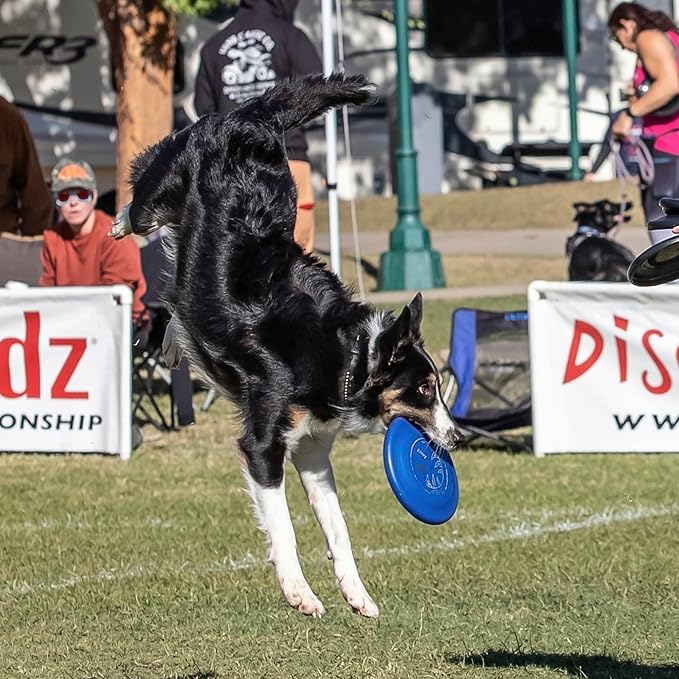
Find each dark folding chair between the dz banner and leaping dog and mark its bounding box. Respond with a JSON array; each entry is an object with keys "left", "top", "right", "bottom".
[{"left": 132, "top": 238, "right": 195, "bottom": 431}]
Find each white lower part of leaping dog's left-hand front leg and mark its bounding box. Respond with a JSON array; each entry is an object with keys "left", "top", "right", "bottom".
[{"left": 245, "top": 470, "right": 325, "bottom": 618}]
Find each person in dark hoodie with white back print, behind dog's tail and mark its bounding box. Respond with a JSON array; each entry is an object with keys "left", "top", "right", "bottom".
[{"left": 194, "top": 0, "right": 323, "bottom": 252}]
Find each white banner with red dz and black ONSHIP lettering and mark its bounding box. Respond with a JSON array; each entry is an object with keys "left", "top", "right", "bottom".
[{"left": 0, "top": 285, "right": 132, "bottom": 458}]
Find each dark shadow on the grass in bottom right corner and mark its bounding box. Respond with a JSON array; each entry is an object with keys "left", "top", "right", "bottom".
[{"left": 446, "top": 649, "right": 679, "bottom": 679}]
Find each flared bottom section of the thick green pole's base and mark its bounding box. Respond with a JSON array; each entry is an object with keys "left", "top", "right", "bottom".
[{"left": 377, "top": 250, "right": 446, "bottom": 290}]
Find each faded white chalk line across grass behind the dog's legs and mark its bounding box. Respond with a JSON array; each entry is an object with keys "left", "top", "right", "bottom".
[{"left": 0, "top": 504, "right": 679, "bottom": 596}]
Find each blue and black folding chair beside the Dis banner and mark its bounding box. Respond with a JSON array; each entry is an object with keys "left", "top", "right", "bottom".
[{"left": 444, "top": 308, "right": 532, "bottom": 450}]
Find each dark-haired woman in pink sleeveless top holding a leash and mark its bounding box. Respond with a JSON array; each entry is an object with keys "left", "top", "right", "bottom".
[{"left": 608, "top": 2, "right": 679, "bottom": 242}]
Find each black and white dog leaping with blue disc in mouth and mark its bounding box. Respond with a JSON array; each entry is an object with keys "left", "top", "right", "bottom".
[{"left": 111, "top": 75, "right": 462, "bottom": 617}]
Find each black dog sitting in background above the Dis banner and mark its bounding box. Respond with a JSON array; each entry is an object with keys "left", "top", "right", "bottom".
[{"left": 566, "top": 199, "right": 634, "bottom": 283}]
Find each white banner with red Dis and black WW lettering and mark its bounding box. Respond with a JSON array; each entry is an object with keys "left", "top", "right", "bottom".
[{"left": 528, "top": 281, "right": 679, "bottom": 455}]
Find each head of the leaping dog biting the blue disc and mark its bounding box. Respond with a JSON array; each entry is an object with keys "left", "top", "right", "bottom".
[{"left": 353, "top": 293, "right": 464, "bottom": 450}]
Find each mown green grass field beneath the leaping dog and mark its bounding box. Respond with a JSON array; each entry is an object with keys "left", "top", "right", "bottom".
[{"left": 0, "top": 297, "right": 679, "bottom": 679}]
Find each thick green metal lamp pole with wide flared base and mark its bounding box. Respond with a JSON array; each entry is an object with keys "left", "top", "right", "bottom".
[{"left": 378, "top": 0, "right": 446, "bottom": 290}]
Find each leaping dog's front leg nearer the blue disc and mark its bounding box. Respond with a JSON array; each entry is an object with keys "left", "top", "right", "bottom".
[{"left": 292, "top": 434, "right": 380, "bottom": 618}]
